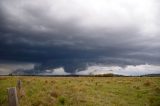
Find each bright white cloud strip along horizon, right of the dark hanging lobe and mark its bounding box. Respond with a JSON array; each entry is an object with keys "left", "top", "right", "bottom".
[{"left": 76, "top": 64, "right": 160, "bottom": 76}]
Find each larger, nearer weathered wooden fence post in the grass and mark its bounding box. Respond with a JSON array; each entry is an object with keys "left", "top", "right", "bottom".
[{"left": 8, "top": 87, "right": 18, "bottom": 106}]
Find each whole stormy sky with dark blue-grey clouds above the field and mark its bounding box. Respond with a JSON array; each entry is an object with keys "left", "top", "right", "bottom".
[{"left": 0, "top": 0, "right": 160, "bottom": 75}]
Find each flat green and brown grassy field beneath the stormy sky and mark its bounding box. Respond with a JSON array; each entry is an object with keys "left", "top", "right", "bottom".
[{"left": 0, "top": 76, "right": 160, "bottom": 106}]
